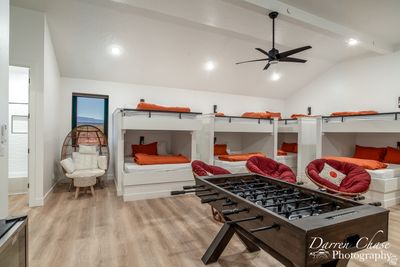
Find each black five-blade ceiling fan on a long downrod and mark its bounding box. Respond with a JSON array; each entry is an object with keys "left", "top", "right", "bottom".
[{"left": 236, "top": 11, "right": 311, "bottom": 70}]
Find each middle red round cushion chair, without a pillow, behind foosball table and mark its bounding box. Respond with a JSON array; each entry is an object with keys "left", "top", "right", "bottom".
[{"left": 246, "top": 156, "right": 296, "bottom": 183}]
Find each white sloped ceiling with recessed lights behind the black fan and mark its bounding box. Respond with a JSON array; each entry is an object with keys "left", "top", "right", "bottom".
[{"left": 12, "top": 0, "right": 400, "bottom": 98}]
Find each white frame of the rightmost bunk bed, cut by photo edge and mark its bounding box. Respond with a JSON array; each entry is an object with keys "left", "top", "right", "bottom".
[{"left": 317, "top": 112, "right": 400, "bottom": 207}]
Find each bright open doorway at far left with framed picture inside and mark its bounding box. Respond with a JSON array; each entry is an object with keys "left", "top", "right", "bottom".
[{"left": 8, "top": 66, "right": 30, "bottom": 206}]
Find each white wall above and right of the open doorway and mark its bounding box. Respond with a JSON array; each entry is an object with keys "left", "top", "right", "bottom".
[{"left": 10, "top": 6, "right": 44, "bottom": 206}]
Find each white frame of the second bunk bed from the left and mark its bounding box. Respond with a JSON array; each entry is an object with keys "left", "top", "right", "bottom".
[{"left": 203, "top": 115, "right": 277, "bottom": 173}]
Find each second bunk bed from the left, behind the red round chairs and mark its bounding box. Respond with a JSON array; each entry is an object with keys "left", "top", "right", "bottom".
[{"left": 209, "top": 116, "right": 277, "bottom": 173}]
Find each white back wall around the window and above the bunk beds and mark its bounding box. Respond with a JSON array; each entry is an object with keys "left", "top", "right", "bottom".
[{"left": 58, "top": 77, "right": 284, "bottom": 177}]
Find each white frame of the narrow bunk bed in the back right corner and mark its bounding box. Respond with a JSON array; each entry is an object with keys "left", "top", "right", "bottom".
[{"left": 275, "top": 117, "right": 319, "bottom": 183}]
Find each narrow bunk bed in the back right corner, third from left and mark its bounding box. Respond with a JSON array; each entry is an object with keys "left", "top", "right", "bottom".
[{"left": 275, "top": 117, "right": 318, "bottom": 182}]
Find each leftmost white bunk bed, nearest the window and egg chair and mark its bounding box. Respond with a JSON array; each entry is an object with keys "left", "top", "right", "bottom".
[{"left": 113, "top": 108, "right": 202, "bottom": 201}]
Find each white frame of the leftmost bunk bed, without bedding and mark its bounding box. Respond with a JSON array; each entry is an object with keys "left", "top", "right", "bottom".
[{"left": 113, "top": 109, "right": 202, "bottom": 201}]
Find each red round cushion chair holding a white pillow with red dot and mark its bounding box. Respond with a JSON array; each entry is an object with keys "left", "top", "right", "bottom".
[{"left": 306, "top": 159, "right": 371, "bottom": 196}]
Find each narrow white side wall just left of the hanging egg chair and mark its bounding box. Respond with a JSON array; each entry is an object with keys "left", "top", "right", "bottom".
[{"left": 43, "top": 17, "right": 61, "bottom": 194}]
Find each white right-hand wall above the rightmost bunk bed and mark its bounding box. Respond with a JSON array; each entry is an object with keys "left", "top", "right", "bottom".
[{"left": 285, "top": 51, "right": 400, "bottom": 115}]
